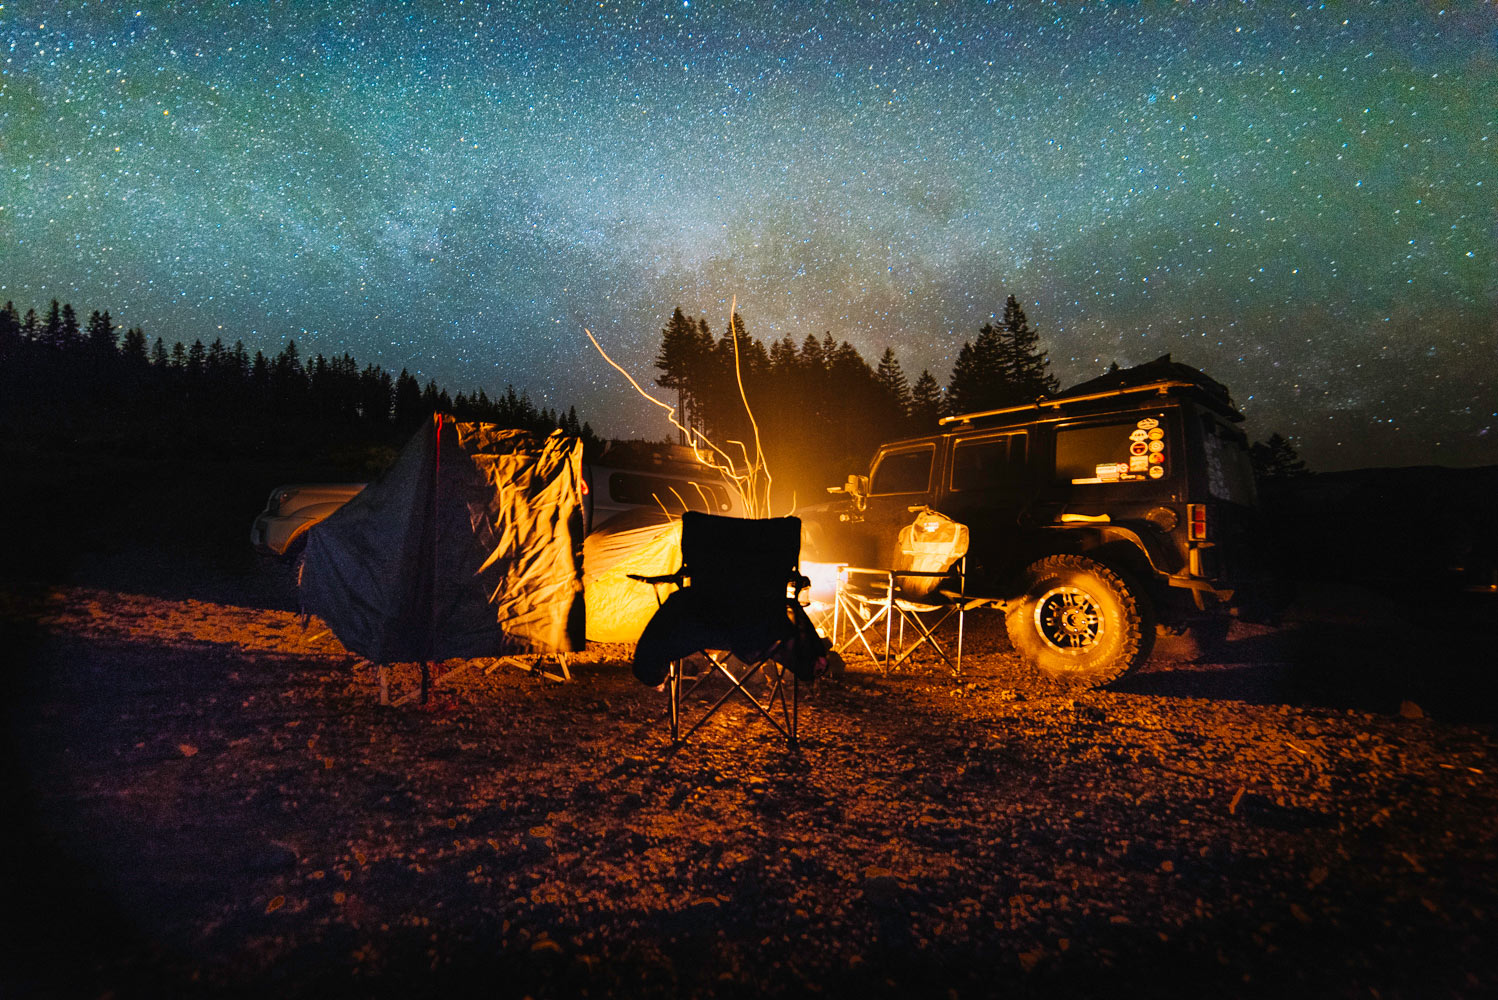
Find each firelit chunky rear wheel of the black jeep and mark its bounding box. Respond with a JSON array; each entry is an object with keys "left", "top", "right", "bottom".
[{"left": 1004, "top": 555, "right": 1155, "bottom": 687}]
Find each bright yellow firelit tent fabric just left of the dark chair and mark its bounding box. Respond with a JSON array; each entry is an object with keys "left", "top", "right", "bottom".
[{"left": 583, "top": 507, "right": 682, "bottom": 642}]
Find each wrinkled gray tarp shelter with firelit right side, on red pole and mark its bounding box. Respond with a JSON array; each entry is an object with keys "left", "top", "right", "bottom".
[{"left": 301, "top": 415, "right": 584, "bottom": 663}]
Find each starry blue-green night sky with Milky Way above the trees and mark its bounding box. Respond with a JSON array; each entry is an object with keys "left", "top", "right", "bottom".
[{"left": 0, "top": 0, "right": 1498, "bottom": 470}]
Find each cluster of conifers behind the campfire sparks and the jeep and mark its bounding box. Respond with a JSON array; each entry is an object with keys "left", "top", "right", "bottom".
[{"left": 656, "top": 295, "right": 1058, "bottom": 501}]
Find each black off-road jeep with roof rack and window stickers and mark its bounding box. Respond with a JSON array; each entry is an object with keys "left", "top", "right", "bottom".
[{"left": 803, "top": 355, "right": 1267, "bottom": 687}]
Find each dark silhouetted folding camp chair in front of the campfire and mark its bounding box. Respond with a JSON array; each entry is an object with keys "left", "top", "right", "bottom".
[{"left": 631, "top": 510, "right": 825, "bottom": 747}]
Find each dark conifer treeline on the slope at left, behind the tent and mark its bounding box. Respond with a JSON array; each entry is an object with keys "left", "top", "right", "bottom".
[{"left": 0, "top": 299, "right": 598, "bottom": 445}]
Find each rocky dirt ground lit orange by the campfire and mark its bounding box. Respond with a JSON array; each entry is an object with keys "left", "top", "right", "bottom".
[{"left": 0, "top": 455, "right": 1498, "bottom": 997}]
